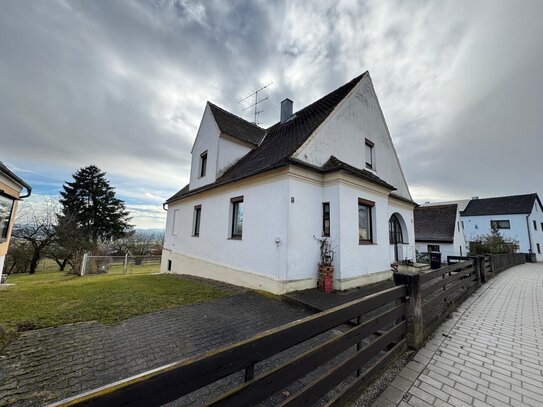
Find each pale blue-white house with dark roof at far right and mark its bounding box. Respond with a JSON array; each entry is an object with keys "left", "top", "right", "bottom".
[{"left": 461, "top": 194, "right": 543, "bottom": 261}]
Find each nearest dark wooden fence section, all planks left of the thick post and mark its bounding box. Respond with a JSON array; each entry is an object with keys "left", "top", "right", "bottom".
[{"left": 53, "top": 285, "right": 407, "bottom": 407}]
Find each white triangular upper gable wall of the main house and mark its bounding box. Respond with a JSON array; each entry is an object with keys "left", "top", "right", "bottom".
[{"left": 294, "top": 77, "right": 411, "bottom": 199}]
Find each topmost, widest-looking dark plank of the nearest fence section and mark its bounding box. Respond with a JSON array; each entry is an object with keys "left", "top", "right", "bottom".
[{"left": 53, "top": 286, "right": 406, "bottom": 407}]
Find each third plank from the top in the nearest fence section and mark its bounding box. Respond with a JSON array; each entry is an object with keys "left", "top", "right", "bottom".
[{"left": 279, "top": 321, "right": 406, "bottom": 407}]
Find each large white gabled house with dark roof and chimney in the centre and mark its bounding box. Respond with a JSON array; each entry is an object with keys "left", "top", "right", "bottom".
[{"left": 162, "top": 72, "right": 416, "bottom": 293}]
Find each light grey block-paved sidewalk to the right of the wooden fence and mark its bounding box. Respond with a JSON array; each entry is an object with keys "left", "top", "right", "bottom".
[{"left": 374, "top": 263, "right": 543, "bottom": 407}]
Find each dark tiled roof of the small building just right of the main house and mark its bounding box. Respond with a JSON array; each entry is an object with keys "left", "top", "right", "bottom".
[{"left": 415, "top": 204, "right": 458, "bottom": 243}]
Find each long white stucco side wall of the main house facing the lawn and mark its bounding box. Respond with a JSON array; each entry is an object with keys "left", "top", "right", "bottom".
[{"left": 163, "top": 175, "right": 288, "bottom": 279}]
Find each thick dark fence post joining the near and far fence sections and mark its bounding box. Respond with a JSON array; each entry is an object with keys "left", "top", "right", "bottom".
[{"left": 394, "top": 271, "right": 424, "bottom": 349}]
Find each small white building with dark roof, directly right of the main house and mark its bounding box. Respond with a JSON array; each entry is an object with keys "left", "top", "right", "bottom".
[{"left": 415, "top": 204, "right": 467, "bottom": 262}]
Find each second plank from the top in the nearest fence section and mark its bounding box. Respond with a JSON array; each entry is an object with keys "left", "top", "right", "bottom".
[{"left": 209, "top": 304, "right": 406, "bottom": 407}]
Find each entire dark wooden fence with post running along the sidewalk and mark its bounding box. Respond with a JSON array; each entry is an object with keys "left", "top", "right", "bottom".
[{"left": 51, "top": 254, "right": 525, "bottom": 407}]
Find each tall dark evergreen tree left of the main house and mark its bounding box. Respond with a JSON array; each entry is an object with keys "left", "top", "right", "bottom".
[{"left": 59, "top": 165, "right": 132, "bottom": 243}]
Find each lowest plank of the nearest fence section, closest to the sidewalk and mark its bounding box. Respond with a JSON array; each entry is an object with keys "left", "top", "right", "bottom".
[{"left": 323, "top": 339, "right": 407, "bottom": 407}]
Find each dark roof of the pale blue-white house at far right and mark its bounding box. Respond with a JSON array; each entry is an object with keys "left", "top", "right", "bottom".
[{"left": 462, "top": 194, "right": 541, "bottom": 216}]
